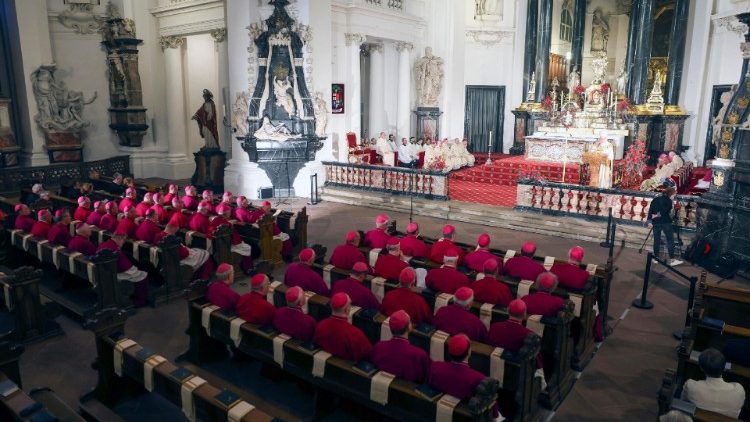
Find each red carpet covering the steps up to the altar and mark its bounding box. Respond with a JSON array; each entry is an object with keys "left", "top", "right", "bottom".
[{"left": 448, "top": 154, "right": 580, "bottom": 207}]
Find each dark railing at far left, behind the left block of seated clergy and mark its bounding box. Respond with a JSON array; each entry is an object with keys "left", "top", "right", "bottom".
[{"left": 0, "top": 155, "right": 130, "bottom": 193}]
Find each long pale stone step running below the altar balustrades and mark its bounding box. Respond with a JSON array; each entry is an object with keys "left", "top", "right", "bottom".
[{"left": 321, "top": 187, "right": 689, "bottom": 250}]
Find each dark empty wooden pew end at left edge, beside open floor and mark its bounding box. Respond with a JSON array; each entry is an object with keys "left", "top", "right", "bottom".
[{"left": 0, "top": 267, "right": 62, "bottom": 343}]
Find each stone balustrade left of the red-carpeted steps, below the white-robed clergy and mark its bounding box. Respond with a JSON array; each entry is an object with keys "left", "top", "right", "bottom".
[{"left": 323, "top": 161, "right": 448, "bottom": 201}]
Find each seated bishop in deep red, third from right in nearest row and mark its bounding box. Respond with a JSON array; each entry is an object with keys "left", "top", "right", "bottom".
[{"left": 313, "top": 293, "right": 372, "bottom": 361}]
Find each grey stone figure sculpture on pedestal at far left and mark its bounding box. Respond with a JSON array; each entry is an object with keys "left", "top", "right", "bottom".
[{"left": 31, "top": 64, "right": 97, "bottom": 132}]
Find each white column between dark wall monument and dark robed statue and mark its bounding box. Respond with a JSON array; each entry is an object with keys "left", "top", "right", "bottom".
[{"left": 159, "top": 36, "right": 188, "bottom": 163}]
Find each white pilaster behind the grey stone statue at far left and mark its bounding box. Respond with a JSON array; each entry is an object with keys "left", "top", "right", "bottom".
[{"left": 15, "top": 0, "right": 53, "bottom": 166}]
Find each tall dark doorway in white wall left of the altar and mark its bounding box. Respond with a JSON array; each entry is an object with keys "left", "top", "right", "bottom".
[{"left": 464, "top": 85, "right": 505, "bottom": 153}]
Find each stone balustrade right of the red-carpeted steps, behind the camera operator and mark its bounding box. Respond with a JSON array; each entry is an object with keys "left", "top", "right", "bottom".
[{"left": 516, "top": 181, "right": 698, "bottom": 229}]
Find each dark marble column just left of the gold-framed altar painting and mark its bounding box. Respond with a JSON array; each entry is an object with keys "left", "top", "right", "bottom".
[{"left": 630, "top": 0, "right": 656, "bottom": 104}]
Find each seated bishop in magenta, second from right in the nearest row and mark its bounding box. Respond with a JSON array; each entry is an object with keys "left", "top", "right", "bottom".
[{"left": 371, "top": 310, "right": 430, "bottom": 384}]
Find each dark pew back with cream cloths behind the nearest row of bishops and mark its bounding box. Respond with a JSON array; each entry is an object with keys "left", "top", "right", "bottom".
[{"left": 184, "top": 288, "right": 498, "bottom": 421}]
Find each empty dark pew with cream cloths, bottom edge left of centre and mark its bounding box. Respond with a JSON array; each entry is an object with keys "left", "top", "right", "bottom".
[{"left": 81, "top": 309, "right": 273, "bottom": 422}]
